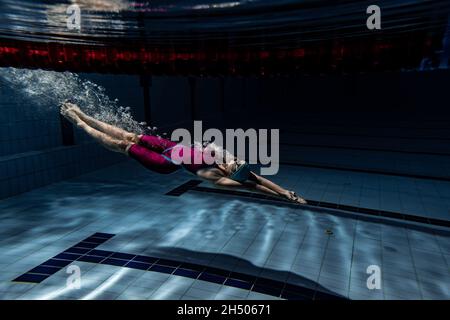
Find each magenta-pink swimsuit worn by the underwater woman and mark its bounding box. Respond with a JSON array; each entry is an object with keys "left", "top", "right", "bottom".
[{"left": 128, "top": 135, "right": 215, "bottom": 174}]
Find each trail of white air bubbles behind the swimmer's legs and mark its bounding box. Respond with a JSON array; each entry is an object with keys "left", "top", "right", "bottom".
[{"left": 0, "top": 68, "right": 156, "bottom": 134}]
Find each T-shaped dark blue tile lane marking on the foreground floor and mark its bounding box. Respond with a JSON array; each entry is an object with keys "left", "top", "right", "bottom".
[{"left": 13, "top": 233, "right": 345, "bottom": 300}]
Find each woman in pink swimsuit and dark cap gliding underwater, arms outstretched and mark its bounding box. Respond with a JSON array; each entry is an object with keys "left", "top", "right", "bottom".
[{"left": 61, "top": 102, "right": 306, "bottom": 204}]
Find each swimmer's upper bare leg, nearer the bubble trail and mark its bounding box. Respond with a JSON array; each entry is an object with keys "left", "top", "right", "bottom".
[{"left": 61, "top": 102, "right": 140, "bottom": 143}]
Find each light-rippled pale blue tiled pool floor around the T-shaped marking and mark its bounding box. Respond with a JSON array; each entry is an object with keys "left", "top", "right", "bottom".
[{"left": 0, "top": 161, "right": 450, "bottom": 300}]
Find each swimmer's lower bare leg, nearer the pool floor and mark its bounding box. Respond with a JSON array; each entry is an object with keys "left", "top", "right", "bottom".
[{"left": 61, "top": 110, "right": 133, "bottom": 154}]
